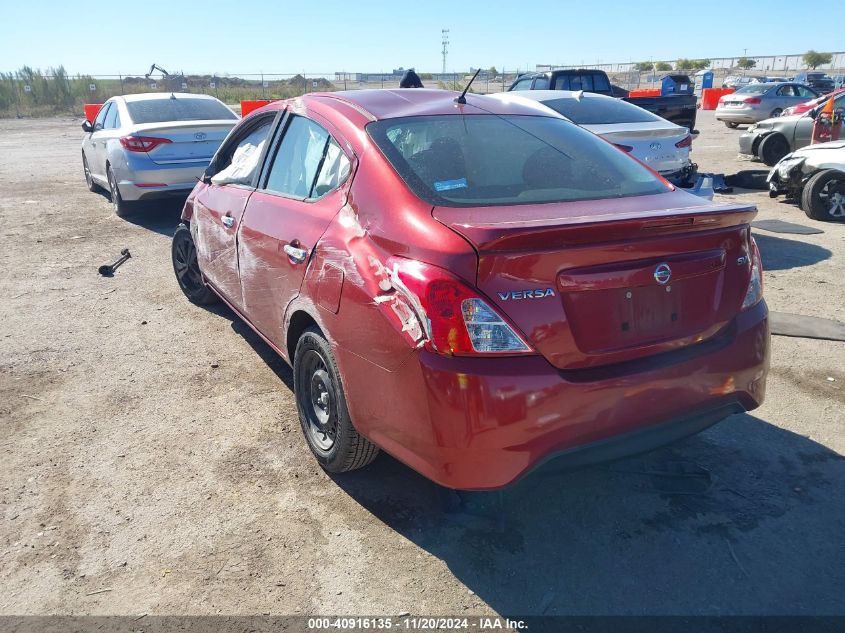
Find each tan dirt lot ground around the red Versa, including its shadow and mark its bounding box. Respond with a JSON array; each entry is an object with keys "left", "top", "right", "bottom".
[{"left": 0, "top": 112, "right": 845, "bottom": 615}]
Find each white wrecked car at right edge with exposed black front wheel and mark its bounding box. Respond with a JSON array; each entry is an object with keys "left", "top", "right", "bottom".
[{"left": 768, "top": 141, "right": 845, "bottom": 222}]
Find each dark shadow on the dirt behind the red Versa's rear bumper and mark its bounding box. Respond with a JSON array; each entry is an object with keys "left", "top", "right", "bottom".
[{"left": 328, "top": 415, "right": 845, "bottom": 615}]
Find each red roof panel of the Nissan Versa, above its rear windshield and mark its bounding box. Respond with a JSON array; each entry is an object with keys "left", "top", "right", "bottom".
[{"left": 312, "top": 88, "right": 554, "bottom": 119}]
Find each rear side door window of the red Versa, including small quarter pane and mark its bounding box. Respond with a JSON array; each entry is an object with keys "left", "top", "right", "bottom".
[{"left": 265, "top": 116, "right": 349, "bottom": 200}]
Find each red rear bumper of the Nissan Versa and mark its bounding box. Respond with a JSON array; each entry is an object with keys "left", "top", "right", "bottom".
[{"left": 338, "top": 302, "right": 769, "bottom": 490}]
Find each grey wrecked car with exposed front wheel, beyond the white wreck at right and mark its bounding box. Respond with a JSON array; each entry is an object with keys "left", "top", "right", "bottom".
[{"left": 739, "top": 92, "right": 845, "bottom": 167}]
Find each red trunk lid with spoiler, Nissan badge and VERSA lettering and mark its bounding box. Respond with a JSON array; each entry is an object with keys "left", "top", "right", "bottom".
[{"left": 432, "top": 192, "right": 756, "bottom": 369}]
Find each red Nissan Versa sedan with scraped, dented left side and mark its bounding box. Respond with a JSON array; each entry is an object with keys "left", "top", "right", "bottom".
[{"left": 173, "top": 90, "right": 769, "bottom": 489}]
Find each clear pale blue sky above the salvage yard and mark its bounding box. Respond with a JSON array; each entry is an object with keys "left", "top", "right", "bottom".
[{"left": 0, "top": 0, "right": 845, "bottom": 75}]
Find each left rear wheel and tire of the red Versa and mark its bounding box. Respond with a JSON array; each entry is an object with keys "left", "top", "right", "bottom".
[{"left": 293, "top": 327, "right": 379, "bottom": 473}]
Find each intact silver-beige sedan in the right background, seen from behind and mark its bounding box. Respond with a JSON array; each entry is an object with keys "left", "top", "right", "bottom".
[{"left": 716, "top": 83, "right": 819, "bottom": 128}]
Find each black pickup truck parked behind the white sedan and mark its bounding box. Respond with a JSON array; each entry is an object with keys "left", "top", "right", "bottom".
[{"left": 508, "top": 69, "right": 697, "bottom": 131}]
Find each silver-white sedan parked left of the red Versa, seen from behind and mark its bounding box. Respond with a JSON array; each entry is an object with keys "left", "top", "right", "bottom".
[{"left": 82, "top": 92, "right": 238, "bottom": 216}]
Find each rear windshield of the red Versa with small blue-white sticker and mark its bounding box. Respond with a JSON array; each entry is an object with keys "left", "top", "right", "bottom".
[{"left": 367, "top": 115, "right": 668, "bottom": 207}]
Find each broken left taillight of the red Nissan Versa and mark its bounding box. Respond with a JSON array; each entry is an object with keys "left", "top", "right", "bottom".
[{"left": 389, "top": 258, "right": 534, "bottom": 355}]
